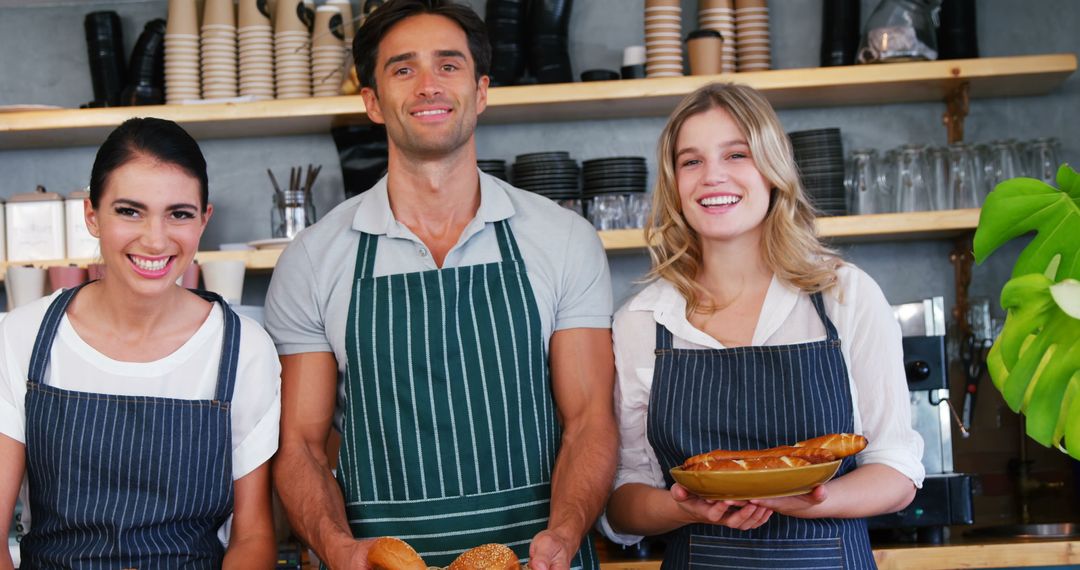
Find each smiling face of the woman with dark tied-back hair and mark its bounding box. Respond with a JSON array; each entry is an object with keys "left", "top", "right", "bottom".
[{"left": 84, "top": 155, "right": 213, "bottom": 296}]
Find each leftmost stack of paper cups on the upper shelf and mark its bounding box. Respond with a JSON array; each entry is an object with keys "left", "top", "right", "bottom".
[{"left": 165, "top": 0, "right": 202, "bottom": 104}]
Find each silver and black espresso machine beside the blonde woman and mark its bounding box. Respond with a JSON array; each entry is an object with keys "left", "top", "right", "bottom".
[{"left": 868, "top": 297, "right": 973, "bottom": 544}]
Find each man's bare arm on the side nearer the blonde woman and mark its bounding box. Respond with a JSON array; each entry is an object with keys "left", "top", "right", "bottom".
[{"left": 529, "top": 328, "right": 619, "bottom": 570}]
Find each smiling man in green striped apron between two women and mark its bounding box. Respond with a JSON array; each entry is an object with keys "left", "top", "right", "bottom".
[{"left": 267, "top": 0, "right": 618, "bottom": 570}]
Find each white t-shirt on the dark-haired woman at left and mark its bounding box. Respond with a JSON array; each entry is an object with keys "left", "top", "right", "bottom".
[{"left": 0, "top": 291, "right": 281, "bottom": 541}]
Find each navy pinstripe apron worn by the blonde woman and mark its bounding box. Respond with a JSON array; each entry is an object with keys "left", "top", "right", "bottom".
[{"left": 647, "top": 294, "right": 877, "bottom": 569}]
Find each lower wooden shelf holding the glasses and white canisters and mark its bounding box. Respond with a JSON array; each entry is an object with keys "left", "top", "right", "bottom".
[{"left": 0, "top": 209, "right": 978, "bottom": 281}]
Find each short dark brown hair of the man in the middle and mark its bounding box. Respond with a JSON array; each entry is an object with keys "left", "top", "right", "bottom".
[{"left": 352, "top": 0, "right": 491, "bottom": 89}]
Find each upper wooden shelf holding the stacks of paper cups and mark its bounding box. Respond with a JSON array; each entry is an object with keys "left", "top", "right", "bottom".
[{"left": 0, "top": 54, "right": 1077, "bottom": 149}]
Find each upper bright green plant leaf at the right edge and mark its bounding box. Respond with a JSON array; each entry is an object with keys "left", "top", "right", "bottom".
[{"left": 974, "top": 164, "right": 1080, "bottom": 282}]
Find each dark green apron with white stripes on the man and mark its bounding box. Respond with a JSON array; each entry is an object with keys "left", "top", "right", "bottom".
[{"left": 337, "top": 220, "right": 598, "bottom": 569}]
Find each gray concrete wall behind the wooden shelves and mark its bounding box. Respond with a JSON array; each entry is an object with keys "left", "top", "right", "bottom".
[{"left": 0, "top": 0, "right": 1080, "bottom": 310}]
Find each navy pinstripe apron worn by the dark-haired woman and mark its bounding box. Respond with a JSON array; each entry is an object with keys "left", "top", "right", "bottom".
[{"left": 22, "top": 286, "right": 240, "bottom": 569}]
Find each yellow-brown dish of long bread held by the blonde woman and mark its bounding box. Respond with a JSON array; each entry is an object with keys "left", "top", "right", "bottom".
[{"left": 671, "top": 434, "right": 866, "bottom": 501}]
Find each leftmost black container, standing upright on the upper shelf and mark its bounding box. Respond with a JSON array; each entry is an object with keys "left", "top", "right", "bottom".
[{"left": 83, "top": 11, "right": 127, "bottom": 107}]
